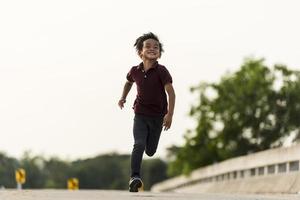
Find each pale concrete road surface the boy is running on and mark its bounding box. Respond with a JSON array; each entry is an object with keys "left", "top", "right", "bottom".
[{"left": 0, "top": 190, "right": 300, "bottom": 200}]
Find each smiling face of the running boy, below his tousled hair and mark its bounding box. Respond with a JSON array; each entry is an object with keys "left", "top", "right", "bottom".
[{"left": 139, "top": 39, "right": 160, "bottom": 60}]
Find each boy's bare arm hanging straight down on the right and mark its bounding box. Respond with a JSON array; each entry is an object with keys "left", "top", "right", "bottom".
[{"left": 163, "top": 83, "right": 175, "bottom": 130}]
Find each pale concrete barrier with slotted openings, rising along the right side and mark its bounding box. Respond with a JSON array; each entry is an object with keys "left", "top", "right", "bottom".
[{"left": 152, "top": 144, "right": 300, "bottom": 193}]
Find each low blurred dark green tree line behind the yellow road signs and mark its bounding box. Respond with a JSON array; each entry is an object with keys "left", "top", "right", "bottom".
[{"left": 0, "top": 152, "right": 167, "bottom": 190}]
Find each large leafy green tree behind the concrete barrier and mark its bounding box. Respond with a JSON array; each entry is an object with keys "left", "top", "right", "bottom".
[{"left": 168, "top": 59, "right": 300, "bottom": 175}]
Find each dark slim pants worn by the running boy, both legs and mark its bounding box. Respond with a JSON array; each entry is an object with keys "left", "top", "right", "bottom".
[{"left": 131, "top": 114, "right": 163, "bottom": 177}]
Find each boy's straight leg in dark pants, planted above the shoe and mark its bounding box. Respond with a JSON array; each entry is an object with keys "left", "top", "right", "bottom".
[{"left": 131, "top": 115, "right": 148, "bottom": 177}]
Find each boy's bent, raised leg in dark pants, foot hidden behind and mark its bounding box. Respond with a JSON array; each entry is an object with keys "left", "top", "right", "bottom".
[{"left": 146, "top": 117, "right": 163, "bottom": 156}]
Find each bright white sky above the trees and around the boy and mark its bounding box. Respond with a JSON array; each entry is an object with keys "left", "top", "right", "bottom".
[{"left": 0, "top": 0, "right": 300, "bottom": 159}]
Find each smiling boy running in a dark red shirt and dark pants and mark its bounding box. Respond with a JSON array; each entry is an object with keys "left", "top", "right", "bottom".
[{"left": 118, "top": 32, "right": 175, "bottom": 192}]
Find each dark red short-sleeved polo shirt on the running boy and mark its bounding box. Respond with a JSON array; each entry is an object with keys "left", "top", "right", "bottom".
[{"left": 127, "top": 62, "right": 172, "bottom": 116}]
